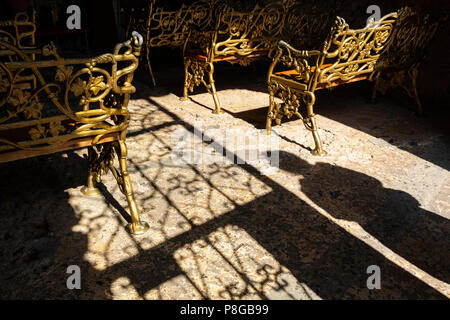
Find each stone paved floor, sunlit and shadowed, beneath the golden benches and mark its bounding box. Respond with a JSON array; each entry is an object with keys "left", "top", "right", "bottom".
[{"left": 0, "top": 63, "right": 450, "bottom": 299}]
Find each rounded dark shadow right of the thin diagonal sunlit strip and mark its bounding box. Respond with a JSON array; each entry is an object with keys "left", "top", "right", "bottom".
[{"left": 280, "top": 151, "right": 450, "bottom": 283}]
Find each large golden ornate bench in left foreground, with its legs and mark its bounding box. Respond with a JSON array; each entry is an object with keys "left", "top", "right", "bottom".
[{"left": 0, "top": 33, "right": 148, "bottom": 234}]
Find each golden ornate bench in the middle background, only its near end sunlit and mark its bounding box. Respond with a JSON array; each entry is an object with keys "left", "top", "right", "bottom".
[{"left": 182, "top": 1, "right": 286, "bottom": 113}]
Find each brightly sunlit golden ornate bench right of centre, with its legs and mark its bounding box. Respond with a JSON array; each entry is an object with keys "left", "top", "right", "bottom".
[{"left": 266, "top": 13, "right": 397, "bottom": 155}]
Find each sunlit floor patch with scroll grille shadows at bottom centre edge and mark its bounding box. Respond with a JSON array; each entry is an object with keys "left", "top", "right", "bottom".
[{"left": 174, "top": 225, "right": 320, "bottom": 299}]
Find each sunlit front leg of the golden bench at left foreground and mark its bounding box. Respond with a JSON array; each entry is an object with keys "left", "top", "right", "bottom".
[{"left": 116, "top": 140, "right": 149, "bottom": 235}]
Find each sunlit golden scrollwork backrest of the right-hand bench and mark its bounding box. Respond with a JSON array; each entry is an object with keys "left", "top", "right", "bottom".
[{"left": 316, "top": 12, "right": 397, "bottom": 83}]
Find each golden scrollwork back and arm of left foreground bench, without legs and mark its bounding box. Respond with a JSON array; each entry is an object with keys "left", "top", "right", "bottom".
[{"left": 0, "top": 34, "right": 142, "bottom": 152}]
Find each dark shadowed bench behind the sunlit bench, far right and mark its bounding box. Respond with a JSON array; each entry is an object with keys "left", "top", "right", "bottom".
[{"left": 371, "top": 7, "right": 448, "bottom": 115}]
